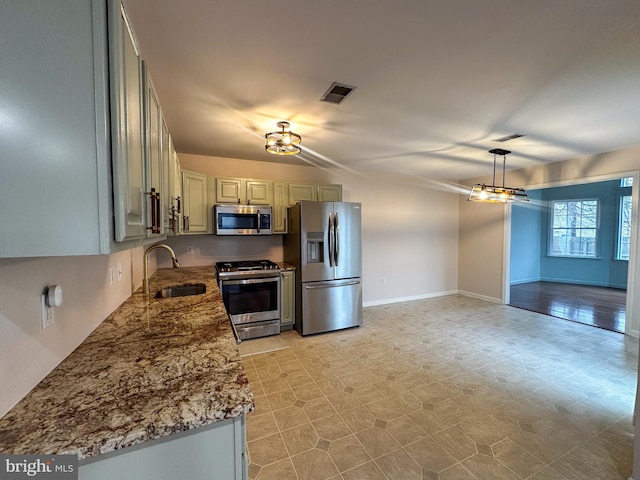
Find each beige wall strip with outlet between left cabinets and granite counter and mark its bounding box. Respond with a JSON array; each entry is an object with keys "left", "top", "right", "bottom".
[{"left": 0, "top": 250, "right": 137, "bottom": 417}]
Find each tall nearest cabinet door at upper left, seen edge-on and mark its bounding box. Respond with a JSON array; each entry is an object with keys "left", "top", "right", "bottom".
[{"left": 109, "top": 2, "right": 147, "bottom": 241}]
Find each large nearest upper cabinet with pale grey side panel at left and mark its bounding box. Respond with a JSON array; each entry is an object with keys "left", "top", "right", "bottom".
[{"left": 0, "top": 0, "right": 138, "bottom": 257}]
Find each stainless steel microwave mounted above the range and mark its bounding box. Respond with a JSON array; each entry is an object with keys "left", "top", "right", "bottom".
[{"left": 213, "top": 205, "right": 271, "bottom": 235}]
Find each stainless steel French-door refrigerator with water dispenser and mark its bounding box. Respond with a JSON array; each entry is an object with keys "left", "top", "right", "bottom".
[{"left": 284, "top": 201, "right": 362, "bottom": 335}]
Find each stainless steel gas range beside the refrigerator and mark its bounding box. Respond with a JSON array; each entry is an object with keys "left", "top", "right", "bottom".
[{"left": 216, "top": 260, "right": 280, "bottom": 340}]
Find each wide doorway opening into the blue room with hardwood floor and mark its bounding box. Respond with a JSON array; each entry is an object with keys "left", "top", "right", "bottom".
[{"left": 505, "top": 177, "right": 633, "bottom": 333}]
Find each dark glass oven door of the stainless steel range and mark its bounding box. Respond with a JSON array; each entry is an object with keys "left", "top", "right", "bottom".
[{"left": 220, "top": 275, "right": 280, "bottom": 325}]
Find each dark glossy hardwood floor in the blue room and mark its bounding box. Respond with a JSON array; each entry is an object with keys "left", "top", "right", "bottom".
[{"left": 509, "top": 282, "right": 627, "bottom": 333}]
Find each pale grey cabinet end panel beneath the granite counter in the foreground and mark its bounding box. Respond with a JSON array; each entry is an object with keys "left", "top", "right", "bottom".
[{"left": 78, "top": 415, "right": 249, "bottom": 480}]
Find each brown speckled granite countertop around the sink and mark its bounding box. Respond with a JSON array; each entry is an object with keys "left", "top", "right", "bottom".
[{"left": 0, "top": 266, "right": 254, "bottom": 459}]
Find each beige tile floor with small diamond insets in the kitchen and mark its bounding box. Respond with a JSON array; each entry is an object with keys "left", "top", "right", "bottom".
[{"left": 243, "top": 295, "right": 638, "bottom": 480}]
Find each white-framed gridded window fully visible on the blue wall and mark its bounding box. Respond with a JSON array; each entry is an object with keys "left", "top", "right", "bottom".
[{"left": 549, "top": 200, "right": 598, "bottom": 257}]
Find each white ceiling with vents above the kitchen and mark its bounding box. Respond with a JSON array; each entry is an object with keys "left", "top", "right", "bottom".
[{"left": 125, "top": 0, "right": 640, "bottom": 180}]
